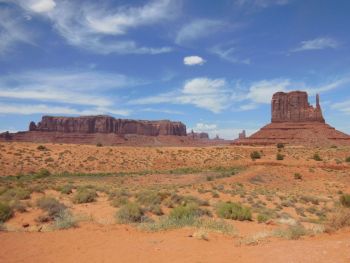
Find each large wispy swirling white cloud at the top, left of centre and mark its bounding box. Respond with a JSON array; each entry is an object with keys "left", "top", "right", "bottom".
[{"left": 8, "top": 0, "right": 179, "bottom": 54}]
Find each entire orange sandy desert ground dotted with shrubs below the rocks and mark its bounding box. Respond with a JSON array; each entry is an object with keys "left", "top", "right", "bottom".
[{"left": 0, "top": 143, "right": 350, "bottom": 263}]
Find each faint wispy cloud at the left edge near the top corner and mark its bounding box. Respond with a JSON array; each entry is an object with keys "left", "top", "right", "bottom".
[{"left": 0, "top": 9, "right": 34, "bottom": 55}]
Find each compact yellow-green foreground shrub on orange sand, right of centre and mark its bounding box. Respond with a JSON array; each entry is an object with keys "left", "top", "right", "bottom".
[{"left": 216, "top": 202, "right": 252, "bottom": 221}]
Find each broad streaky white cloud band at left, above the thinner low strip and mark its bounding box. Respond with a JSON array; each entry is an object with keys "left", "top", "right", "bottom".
[{"left": 0, "top": 70, "right": 139, "bottom": 114}]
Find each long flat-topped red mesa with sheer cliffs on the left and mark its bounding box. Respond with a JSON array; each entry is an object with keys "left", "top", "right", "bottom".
[{"left": 29, "top": 115, "right": 186, "bottom": 136}]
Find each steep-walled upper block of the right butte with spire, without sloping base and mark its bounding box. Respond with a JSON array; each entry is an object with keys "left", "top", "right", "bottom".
[{"left": 271, "top": 91, "right": 325, "bottom": 123}]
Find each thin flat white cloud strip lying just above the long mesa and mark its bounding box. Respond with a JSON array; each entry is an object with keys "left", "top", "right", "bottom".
[{"left": 0, "top": 103, "right": 131, "bottom": 116}]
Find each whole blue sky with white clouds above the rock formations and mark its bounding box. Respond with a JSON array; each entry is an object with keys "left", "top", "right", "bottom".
[{"left": 0, "top": 0, "right": 350, "bottom": 139}]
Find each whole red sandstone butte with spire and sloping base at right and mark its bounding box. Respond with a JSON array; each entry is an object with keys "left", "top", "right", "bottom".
[{"left": 233, "top": 91, "right": 350, "bottom": 145}]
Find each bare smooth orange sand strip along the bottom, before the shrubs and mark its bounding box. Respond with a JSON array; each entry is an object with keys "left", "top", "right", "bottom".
[{"left": 0, "top": 225, "right": 350, "bottom": 263}]
